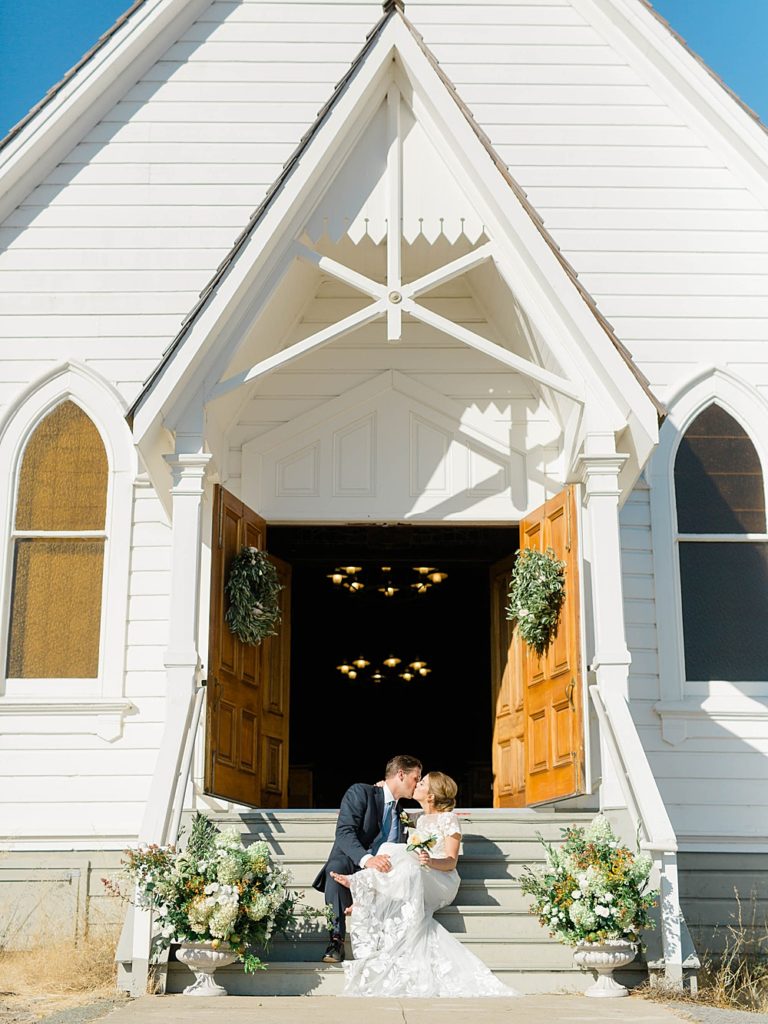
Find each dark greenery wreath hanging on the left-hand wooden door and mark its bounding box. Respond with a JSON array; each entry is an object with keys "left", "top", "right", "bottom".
[{"left": 224, "top": 548, "right": 283, "bottom": 646}]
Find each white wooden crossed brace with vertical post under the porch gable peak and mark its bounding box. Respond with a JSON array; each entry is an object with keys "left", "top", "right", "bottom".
[{"left": 209, "top": 83, "right": 584, "bottom": 402}]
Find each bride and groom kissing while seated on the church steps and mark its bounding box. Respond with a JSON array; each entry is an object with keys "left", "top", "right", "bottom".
[{"left": 313, "top": 754, "right": 518, "bottom": 998}]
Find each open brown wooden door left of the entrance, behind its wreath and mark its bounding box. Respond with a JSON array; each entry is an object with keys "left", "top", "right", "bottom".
[{"left": 205, "top": 486, "right": 291, "bottom": 807}]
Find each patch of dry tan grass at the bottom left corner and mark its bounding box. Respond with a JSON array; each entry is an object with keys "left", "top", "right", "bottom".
[{"left": 0, "top": 932, "right": 126, "bottom": 1024}]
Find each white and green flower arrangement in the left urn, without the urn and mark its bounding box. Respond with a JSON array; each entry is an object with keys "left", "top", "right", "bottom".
[{"left": 102, "top": 814, "right": 322, "bottom": 972}]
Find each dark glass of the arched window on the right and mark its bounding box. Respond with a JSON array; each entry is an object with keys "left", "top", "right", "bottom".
[{"left": 675, "top": 404, "right": 768, "bottom": 681}]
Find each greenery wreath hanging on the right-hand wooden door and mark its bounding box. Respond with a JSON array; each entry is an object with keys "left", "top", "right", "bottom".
[{"left": 507, "top": 548, "right": 565, "bottom": 657}]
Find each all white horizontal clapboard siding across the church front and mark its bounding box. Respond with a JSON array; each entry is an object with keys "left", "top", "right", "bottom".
[{"left": 0, "top": 0, "right": 768, "bottom": 838}]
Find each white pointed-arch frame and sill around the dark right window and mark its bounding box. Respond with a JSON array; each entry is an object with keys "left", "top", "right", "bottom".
[{"left": 646, "top": 366, "right": 768, "bottom": 744}]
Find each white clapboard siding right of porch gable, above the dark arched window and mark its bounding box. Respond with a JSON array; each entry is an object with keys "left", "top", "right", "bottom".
[{"left": 409, "top": 0, "right": 768, "bottom": 399}]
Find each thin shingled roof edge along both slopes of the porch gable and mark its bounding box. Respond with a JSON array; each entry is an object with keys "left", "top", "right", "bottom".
[{"left": 127, "top": 0, "right": 666, "bottom": 424}]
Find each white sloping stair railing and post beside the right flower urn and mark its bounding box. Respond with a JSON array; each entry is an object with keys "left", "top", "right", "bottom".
[{"left": 590, "top": 685, "right": 700, "bottom": 988}]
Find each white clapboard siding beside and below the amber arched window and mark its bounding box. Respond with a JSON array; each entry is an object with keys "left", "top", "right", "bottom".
[{"left": 0, "top": 486, "right": 170, "bottom": 847}]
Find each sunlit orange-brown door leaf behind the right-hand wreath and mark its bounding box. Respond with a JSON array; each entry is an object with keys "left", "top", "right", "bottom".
[{"left": 520, "top": 487, "right": 584, "bottom": 805}]
